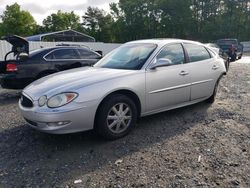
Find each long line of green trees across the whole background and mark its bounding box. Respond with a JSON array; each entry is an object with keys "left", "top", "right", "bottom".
[{"left": 0, "top": 0, "right": 250, "bottom": 43}]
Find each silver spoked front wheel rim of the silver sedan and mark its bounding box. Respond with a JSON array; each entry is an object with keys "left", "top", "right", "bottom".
[{"left": 106, "top": 103, "right": 132, "bottom": 134}]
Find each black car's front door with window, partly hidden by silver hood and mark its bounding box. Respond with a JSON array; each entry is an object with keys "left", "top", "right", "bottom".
[{"left": 77, "top": 48, "right": 102, "bottom": 65}]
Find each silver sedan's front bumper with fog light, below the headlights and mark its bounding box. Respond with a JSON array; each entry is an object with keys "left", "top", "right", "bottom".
[{"left": 19, "top": 101, "right": 97, "bottom": 134}]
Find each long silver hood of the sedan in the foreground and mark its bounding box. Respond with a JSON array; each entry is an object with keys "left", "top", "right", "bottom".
[{"left": 23, "top": 67, "right": 136, "bottom": 100}]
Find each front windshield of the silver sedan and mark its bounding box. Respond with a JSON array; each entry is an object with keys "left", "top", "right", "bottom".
[{"left": 95, "top": 44, "right": 157, "bottom": 70}]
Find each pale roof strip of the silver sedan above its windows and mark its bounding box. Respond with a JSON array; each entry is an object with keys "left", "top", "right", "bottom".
[{"left": 126, "top": 38, "right": 204, "bottom": 46}]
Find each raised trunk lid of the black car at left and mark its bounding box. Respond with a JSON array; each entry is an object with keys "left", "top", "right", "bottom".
[{"left": 2, "top": 35, "right": 29, "bottom": 55}]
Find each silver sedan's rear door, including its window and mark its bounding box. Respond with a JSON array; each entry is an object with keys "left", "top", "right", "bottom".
[{"left": 184, "top": 43, "right": 216, "bottom": 100}]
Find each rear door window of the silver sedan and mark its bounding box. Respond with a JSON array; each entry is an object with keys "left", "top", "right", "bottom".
[{"left": 184, "top": 44, "right": 211, "bottom": 63}]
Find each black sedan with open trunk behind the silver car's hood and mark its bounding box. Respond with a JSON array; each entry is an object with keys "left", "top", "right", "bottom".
[{"left": 0, "top": 36, "right": 102, "bottom": 89}]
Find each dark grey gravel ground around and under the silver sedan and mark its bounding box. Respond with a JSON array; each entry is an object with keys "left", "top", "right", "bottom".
[{"left": 0, "top": 58, "right": 250, "bottom": 188}]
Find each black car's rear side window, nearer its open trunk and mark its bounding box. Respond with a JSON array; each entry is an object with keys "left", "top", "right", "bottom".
[{"left": 49, "top": 49, "right": 79, "bottom": 59}]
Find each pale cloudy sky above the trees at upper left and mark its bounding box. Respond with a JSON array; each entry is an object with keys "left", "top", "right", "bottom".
[{"left": 0, "top": 0, "right": 119, "bottom": 25}]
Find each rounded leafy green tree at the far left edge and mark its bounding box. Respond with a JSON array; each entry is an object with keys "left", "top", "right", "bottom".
[{"left": 0, "top": 3, "right": 36, "bottom": 36}]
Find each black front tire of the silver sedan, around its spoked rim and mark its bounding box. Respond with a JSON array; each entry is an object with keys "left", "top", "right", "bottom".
[{"left": 95, "top": 94, "right": 137, "bottom": 140}]
